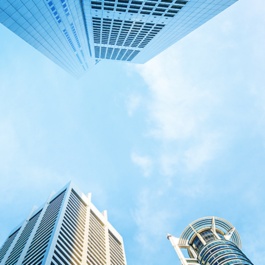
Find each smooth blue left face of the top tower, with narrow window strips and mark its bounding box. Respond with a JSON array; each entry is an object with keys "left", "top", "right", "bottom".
[{"left": 0, "top": 0, "right": 93, "bottom": 76}]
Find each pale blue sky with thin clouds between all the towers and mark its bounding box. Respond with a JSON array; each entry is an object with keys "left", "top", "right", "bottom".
[{"left": 0, "top": 0, "right": 265, "bottom": 265}]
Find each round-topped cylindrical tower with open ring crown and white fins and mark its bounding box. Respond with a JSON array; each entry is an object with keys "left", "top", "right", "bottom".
[{"left": 168, "top": 217, "right": 253, "bottom": 265}]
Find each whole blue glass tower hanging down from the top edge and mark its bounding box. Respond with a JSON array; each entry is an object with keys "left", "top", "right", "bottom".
[{"left": 0, "top": 0, "right": 237, "bottom": 75}]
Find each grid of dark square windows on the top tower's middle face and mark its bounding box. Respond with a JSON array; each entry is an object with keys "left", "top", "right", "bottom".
[{"left": 90, "top": 0, "right": 188, "bottom": 61}]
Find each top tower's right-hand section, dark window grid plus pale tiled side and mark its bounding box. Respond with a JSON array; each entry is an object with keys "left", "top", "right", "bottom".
[{"left": 84, "top": 0, "right": 237, "bottom": 63}]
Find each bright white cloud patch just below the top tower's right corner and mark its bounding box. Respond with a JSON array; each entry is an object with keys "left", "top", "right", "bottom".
[{"left": 133, "top": 48, "right": 223, "bottom": 173}]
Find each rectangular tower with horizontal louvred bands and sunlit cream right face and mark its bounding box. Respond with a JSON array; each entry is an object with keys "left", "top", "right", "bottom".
[{"left": 0, "top": 183, "right": 126, "bottom": 265}]
